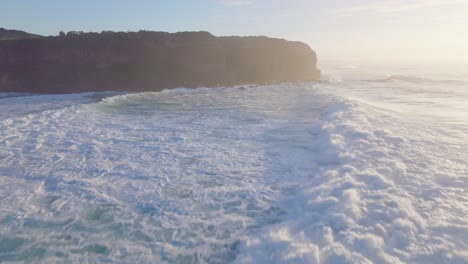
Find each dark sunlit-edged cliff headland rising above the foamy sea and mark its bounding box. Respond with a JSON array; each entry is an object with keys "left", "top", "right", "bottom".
[{"left": 0, "top": 32, "right": 320, "bottom": 93}]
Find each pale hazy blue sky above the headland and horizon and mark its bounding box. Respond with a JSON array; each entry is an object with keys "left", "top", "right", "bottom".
[{"left": 0, "top": 0, "right": 468, "bottom": 61}]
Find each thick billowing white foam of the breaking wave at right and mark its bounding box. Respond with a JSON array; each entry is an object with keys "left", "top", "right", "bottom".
[{"left": 236, "top": 101, "right": 468, "bottom": 263}]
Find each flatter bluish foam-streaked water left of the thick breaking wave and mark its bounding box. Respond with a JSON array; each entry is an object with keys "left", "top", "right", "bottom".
[{"left": 0, "top": 83, "right": 332, "bottom": 262}]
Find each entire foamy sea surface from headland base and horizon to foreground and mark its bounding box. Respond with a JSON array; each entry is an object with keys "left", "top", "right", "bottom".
[{"left": 0, "top": 63, "right": 468, "bottom": 263}]
